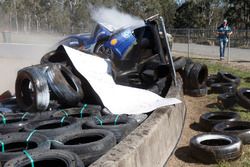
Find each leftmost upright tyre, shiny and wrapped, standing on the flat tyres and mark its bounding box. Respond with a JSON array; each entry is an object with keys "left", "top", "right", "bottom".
[{"left": 15, "top": 66, "right": 50, "bottom": 112}]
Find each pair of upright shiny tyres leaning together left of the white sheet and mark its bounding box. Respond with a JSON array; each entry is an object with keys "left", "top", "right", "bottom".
[{"left": 15, "top": 64, "right": 84, "bottom": 112}]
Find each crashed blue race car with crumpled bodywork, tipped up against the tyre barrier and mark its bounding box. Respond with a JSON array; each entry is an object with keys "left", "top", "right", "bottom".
[{"left": 42, "top": 15, "right": 175, "bottom": 94}]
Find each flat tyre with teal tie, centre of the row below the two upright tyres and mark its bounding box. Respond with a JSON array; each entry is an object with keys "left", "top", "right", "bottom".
[{"left": 24, "top": 117, "right": 80, "bottom": 139}]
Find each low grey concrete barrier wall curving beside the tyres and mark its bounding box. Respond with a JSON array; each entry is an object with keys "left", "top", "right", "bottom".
[{"left": 90, "top": 75, "right": 186, "bottom": 167}]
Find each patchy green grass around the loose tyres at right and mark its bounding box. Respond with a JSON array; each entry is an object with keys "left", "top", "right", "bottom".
[{"left": 194, "top": 59, "right": 250, "bottom": 167}]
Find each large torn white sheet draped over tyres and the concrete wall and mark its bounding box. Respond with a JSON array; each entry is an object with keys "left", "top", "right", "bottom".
[{"left": 64, "top": 46, "right": 181, "bottom": 114}]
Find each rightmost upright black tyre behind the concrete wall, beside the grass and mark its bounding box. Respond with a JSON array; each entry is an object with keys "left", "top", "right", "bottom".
[{"left": 188, "top": 63, "right": 208, "bottom": 89}]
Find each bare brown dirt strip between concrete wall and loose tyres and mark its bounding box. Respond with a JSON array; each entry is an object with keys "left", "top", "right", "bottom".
[{"left": 167, "top": 96, "right": 216, "bottom": 167}]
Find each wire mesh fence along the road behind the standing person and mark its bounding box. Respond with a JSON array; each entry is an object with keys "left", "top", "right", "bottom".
[{"left": 168, "top": 29, "right": 250, "bottom": 61}]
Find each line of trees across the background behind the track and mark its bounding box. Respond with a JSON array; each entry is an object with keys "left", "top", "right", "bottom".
[{"left": 0, "top": 0, "right": 250, "bottom": 36}]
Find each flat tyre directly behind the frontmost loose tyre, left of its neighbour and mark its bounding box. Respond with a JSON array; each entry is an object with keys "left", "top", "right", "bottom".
[{"left": 199, "top": 111, "right": 240, "bottom": 131}]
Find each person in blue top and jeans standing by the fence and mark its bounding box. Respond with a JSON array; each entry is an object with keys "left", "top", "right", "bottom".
[{"left": 217, "top": 20, "right": 232, "bottom": 60}]
